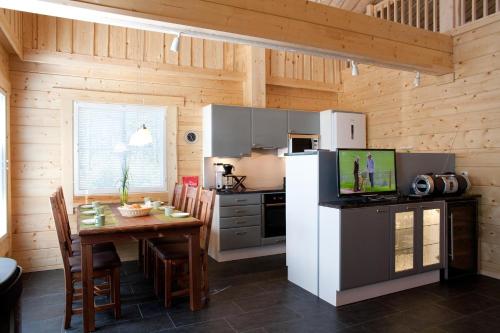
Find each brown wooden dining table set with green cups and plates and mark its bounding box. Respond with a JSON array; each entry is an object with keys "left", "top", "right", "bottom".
[{"left": 77, "top": 204, "right": 202, "bottom": 333}]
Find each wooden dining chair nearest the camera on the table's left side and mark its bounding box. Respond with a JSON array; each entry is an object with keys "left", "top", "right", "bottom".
[{"left": 50, "top": 192, "right": 121, "bottom": 328}]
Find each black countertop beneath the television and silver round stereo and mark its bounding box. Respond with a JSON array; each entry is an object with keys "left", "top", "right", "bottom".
[{"left": 319, "top": 195, "right": 481, "bottom": 209}]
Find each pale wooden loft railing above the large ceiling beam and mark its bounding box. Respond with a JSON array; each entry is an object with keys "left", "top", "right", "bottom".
[{"left": 366, "top": 0, "right": 500, "bottom": 32}]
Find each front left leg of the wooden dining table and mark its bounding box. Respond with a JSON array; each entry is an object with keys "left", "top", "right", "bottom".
[{"left": 81, "top": 243, "right": 95, "bottom": 333}]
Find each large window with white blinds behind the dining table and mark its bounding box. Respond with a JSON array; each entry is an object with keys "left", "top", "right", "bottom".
[{"left": 74, "top": 102, "right": 167, "bottom": 195}]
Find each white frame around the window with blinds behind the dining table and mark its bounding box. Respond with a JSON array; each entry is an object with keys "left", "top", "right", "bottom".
[{"left": 73, "top": 101, "right": 168, "bottom": 196}]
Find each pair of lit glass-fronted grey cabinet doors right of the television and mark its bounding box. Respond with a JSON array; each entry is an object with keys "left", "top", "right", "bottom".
[{"left": 390, "top": 201, "right": 445, "bottom": 279}]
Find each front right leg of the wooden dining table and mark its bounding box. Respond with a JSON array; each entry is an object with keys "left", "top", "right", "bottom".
[{"left": 189, "top": 228, "right": 201, "bottom": 311}]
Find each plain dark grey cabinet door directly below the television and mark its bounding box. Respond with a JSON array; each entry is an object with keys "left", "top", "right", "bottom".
[{"left": 340, "top": 206, "right": 391, "bottom": 290}]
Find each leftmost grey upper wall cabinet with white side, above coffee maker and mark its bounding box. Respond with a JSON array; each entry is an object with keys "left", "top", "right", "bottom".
[{"left": 203, "top": 104, "right": 252, "bottom": 157}]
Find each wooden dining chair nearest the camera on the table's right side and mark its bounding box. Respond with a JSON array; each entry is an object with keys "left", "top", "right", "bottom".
[{"left": 154, "top": 190, "right": 216, "bottom": 307}]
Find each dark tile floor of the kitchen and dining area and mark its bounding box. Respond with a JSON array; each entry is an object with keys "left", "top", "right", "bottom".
[{"left": 22, "top": 256, "right": 500, "bottom": 333}]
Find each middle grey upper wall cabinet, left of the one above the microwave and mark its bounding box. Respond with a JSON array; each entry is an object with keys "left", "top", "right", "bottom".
[{"left": 252, "top": 109, "right": 288, "bottom": 148}]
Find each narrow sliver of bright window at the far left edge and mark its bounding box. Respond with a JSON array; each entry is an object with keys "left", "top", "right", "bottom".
[{"left": 0, "top": 91, "right": 8, "bottom": 237}]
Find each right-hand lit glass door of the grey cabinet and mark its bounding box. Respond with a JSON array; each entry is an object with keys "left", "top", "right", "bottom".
[{"left": 422, "top": 207, "right": 443, "bottom": 267}]
